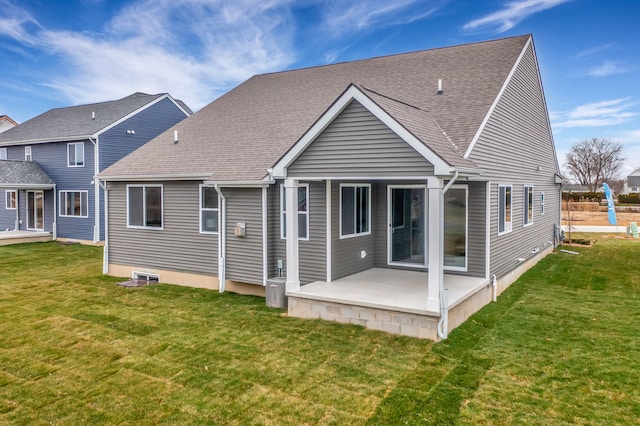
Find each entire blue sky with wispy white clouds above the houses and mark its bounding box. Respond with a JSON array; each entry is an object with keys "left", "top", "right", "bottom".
[{"left": 0, "top": 0, "right": 640, "bottom": 174}]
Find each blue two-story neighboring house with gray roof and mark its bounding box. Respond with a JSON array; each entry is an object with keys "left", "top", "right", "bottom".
[{"left": 0, "top": 93, "right": 191, "bottom": 242}]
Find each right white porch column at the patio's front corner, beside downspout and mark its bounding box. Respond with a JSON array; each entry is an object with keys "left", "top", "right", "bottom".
[{"left": 427, "top": 177, "right": 444, "bottom": 312}]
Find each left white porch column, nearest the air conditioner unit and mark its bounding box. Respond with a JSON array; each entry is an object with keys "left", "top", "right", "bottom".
[{"left": 284, "top": 178, "right": 300, "bottom": 291}]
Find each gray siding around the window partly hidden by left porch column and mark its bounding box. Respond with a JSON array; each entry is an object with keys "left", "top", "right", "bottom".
[{"left": 269, "top": 182, "right": 327, "bottom": 285}]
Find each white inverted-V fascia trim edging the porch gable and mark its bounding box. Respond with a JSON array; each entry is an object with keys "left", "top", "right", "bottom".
[{"left": 273, "top": 85, "right": 453, "bottom": 179}]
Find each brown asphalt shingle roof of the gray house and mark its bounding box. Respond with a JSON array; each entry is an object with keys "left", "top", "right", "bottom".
[{"left": 100, "top": 35, "right": 530, "bottom": 181}]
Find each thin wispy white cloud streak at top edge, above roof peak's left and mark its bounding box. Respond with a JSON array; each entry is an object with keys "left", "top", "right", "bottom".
[{"left": 463, "top": 0, "right": 572, "bottom": 33}]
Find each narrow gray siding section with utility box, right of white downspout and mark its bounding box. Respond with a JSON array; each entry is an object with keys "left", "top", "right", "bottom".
[{"left": 222, "top": 188, "right": 263, "bottom": 285}]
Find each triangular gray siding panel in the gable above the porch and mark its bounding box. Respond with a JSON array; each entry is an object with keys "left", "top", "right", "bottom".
[{"left": 287, "top": 101, "right": 433, "bottom": 177}]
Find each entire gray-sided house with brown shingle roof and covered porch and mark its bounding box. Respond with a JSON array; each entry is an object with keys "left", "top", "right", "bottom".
[{"left": 99, "top": 35, "right": 561, "bottom": 339}]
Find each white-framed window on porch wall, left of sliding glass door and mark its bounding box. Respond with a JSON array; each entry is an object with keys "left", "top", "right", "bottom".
[{"left": 340, "top": 184, "right": 371, "bottom": 238}]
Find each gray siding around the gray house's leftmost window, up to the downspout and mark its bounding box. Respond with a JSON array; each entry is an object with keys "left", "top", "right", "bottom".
[{"left": 108, "top": 182, "right": 218, "bottom": 276}]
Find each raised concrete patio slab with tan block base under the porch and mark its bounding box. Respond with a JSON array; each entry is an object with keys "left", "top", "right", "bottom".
[{"left": 286, "top": 268, "right": 493, "bottom": 340}]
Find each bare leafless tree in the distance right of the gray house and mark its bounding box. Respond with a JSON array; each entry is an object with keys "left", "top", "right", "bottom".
[{"left": 566, "top": 138, "right": 624, "bottom": 192}]
